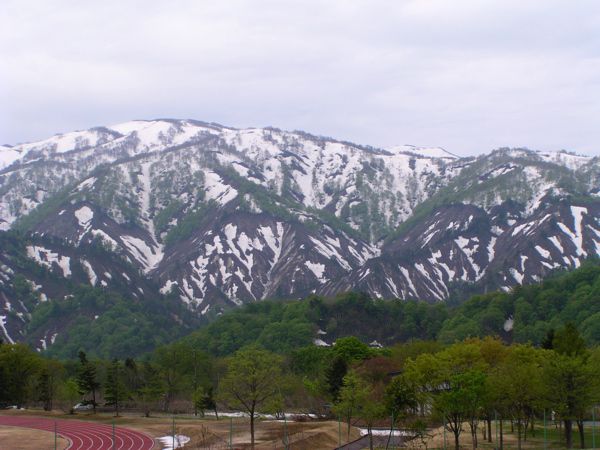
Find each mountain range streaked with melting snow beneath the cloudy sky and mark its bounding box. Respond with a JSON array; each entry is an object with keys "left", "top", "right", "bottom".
[{"left": 0, "top": 120, "right": 600, "bottom": 346}]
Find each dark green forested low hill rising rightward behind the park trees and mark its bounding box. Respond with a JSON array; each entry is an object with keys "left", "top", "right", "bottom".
[{"left": 164, "top": 261, "right": 600, "bottom": 355}]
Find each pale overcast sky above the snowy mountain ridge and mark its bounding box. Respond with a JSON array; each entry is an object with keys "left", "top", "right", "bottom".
[{"left": 0, "top": 0, "right": 600, "bottom": 155}]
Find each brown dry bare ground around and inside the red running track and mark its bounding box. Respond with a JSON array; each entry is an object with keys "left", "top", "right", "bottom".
[{"left": 0, "top": 410, "right": 360, "bottom": 450}]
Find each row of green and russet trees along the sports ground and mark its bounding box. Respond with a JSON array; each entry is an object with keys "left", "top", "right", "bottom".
[{"left": 0, "top": 324, "right": 600, "bottom": 449}]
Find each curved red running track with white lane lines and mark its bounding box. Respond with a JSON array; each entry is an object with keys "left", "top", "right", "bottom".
[{"left": 0, "top": 416, "right": 154, "bottom": 450}]
